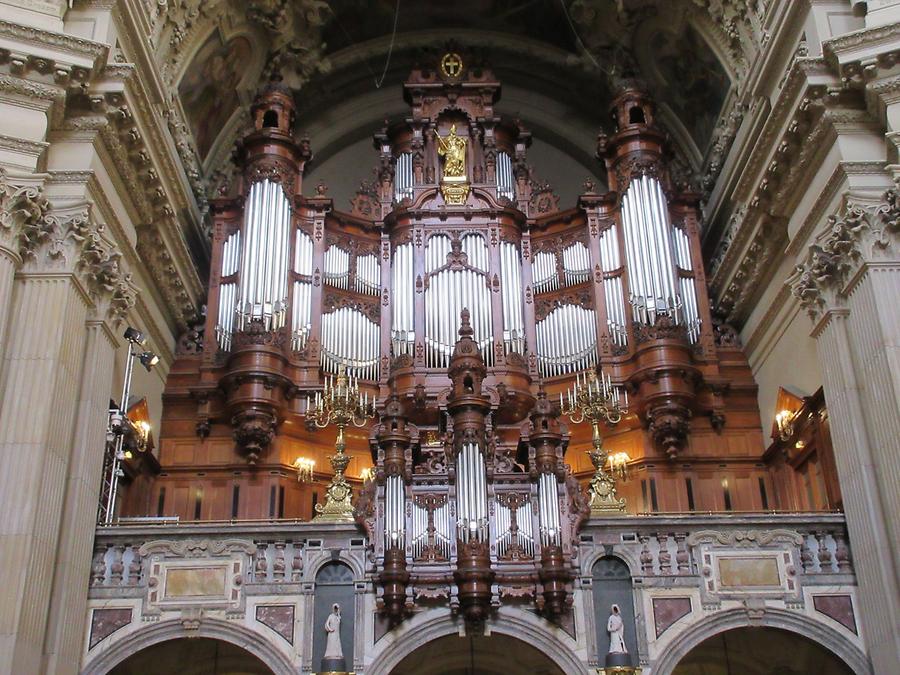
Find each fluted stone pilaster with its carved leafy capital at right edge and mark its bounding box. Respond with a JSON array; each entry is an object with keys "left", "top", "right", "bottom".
[{"left": 790, "top": 184, "right": 900, "bottom": 673}]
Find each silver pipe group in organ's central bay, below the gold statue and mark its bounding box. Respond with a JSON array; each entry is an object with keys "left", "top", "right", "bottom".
[{"left": 425, "top": 234, "right": 494, "bottom": 368}]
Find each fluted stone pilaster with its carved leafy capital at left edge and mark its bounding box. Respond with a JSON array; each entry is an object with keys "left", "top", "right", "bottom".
[{"left": 0, "top": 205, "right": 130, "bottom": 673}]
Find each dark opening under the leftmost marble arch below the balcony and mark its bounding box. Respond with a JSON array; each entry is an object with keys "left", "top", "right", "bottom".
[{"left": 109, "top": 638, "right": 273, "bottom": 675}]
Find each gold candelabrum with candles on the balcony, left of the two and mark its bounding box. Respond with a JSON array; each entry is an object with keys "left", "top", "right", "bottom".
[{"left": 306, "top": 367, "right": 375, "bottom": 523}]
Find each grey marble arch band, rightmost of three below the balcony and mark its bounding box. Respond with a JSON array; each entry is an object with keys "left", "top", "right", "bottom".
[{"left": 653, "top": 608, "right": 872, "bottom": 675}]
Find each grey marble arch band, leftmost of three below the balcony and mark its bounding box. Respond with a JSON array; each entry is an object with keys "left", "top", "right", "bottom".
[{"left": 82, "top": 619, "right": 299, "bottom": 675}]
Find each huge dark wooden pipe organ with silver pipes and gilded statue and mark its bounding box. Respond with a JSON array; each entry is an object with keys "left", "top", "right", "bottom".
[{"left": 126, "top": 56, "right": 779, "bottom": 621}]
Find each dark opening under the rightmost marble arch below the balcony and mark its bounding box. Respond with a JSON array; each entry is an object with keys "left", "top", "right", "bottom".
[{"left": 672, "top": 627, "right": 853, "bottom": 675}]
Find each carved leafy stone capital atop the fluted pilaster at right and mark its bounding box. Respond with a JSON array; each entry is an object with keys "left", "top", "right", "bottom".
[{"left": 786, "top": 186, "right": 900, "bottom": 321}]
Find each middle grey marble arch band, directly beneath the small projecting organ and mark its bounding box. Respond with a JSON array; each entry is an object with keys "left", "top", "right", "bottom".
[{"left": 366, "top": 609, "right": 588, "bottom": 675}]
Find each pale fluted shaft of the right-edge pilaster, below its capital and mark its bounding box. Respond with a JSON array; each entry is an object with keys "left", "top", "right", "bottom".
[{"left": 816, "top": 265, "right": 900, "bottom": 672}]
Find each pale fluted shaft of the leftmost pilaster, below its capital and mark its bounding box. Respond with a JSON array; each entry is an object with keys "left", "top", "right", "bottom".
[{"left": 0, "top": 272, "right": 90, "bottom": 673}]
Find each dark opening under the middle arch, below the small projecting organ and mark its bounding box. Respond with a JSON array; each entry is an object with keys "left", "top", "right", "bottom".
[{"left": 391, "top": 633, "right": 566, "bottom": 675}]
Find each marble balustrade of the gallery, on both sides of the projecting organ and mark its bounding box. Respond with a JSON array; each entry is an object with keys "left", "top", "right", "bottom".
[{"left": 90, "top": 513, "right": 853, "bottom": 589}]
